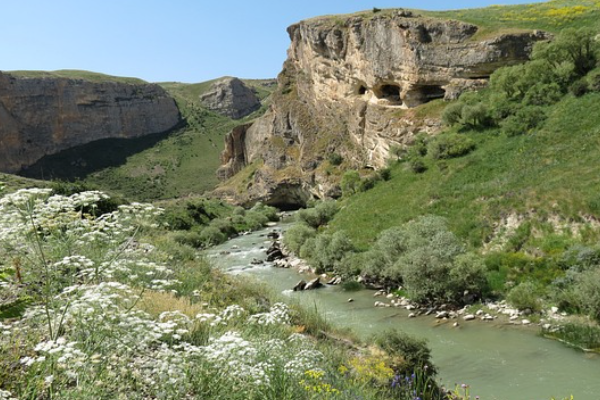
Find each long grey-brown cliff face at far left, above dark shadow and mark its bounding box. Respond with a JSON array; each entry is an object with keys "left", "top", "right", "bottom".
[{"left": 0, "top": 73, "right": 180, "bottom": 172}]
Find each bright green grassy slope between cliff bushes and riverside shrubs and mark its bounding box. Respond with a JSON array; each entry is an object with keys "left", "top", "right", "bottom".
[{"left": 332, "top": 93, "right": 600, "bottom": 248}]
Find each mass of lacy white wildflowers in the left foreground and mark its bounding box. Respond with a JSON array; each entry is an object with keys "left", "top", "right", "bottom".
[{"left": 0, "top": 189, "right": 323, "bottom": 400}]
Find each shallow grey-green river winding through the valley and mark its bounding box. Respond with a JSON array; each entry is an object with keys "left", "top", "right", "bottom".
[{"left": 207, "top": 223, "right": 600, "bottom": 400}]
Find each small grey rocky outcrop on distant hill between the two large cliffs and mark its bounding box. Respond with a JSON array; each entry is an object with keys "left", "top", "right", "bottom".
[{"left": 200, "top": 77, "right": 260, "bottom": 119}]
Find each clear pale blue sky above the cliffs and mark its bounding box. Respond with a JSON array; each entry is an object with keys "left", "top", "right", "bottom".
[{"left": 0, "top": 0, "right": 544, "bottom": 83}]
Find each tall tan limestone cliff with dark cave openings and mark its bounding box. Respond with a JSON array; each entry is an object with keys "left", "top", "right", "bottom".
[{"left": 221, "top": 10, "right": 548, "bottom": 206}]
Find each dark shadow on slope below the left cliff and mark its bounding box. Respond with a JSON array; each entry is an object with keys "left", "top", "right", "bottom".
[{"left": 17, "top": 126, "right": 181, "bottom": 181}]
